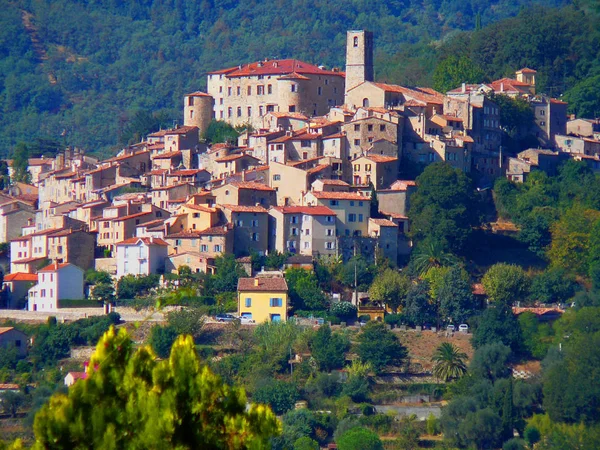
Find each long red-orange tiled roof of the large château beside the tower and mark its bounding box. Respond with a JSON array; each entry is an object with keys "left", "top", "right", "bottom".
[{"left": 208, "top": 59, "right": 344, "bottom": 78}]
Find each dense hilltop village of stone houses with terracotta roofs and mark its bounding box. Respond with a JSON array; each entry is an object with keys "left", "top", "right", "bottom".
[{"left": 0, "top": 31, "right": 600, "bottom": 321}]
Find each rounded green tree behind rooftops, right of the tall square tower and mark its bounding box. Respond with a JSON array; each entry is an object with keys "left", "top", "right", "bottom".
[{"left": 433, "top": 55, "right": 485, "bottom": 94}]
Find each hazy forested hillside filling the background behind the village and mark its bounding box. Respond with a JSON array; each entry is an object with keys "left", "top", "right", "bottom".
[{"left": 5, "top": 0, "right": 600, "bottom": 155}]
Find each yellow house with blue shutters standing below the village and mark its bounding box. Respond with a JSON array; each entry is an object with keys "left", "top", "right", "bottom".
[{"left": 238, "top": 276, "right": 288, "bottom": 323}]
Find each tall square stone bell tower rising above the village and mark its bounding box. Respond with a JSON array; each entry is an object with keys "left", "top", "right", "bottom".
[{"left": 345, "top": 30, "right": 373, "bottom": 98}]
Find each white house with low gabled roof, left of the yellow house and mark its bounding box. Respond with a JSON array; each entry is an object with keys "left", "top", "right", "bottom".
[{"left": 117, "top": 237, "right": 169, "bottom": 278}]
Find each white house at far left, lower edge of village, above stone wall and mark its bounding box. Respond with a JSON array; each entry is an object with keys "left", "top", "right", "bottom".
[{"left": 29, "top": 263, "right": 84, "bottom": 311}]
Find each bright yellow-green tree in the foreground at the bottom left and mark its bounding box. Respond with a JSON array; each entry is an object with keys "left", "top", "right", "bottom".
[{"left": 34, "top": 327, "right": 280, "bottom": 449}]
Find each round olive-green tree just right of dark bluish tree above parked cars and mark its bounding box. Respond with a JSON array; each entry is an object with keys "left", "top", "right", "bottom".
[{"left": 481, "top": 263, "right": 529, "bottom": 306}]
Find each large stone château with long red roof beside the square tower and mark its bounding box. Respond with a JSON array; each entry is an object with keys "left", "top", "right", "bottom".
[{"left": 207, "top": 59, "right": 345, "bottom": 128}]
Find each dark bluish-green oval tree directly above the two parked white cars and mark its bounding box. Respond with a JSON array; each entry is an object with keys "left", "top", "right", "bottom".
[{"left": 437, "top": 268, "right": 477, "bottom": 323}]
